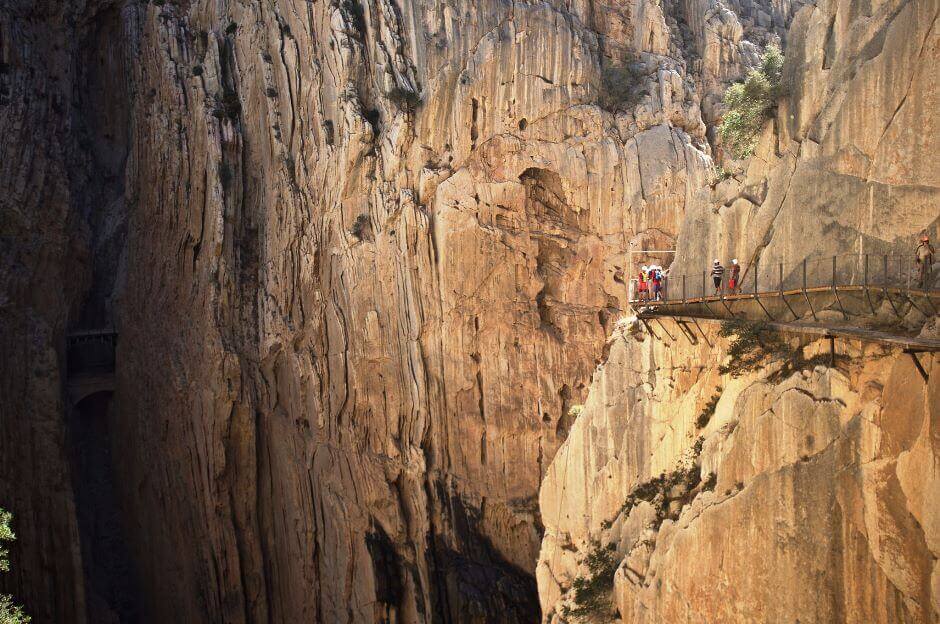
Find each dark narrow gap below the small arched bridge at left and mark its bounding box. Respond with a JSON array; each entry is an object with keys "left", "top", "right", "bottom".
[{"left": 68, "top": 391, "right": 142, "bottom": 624}]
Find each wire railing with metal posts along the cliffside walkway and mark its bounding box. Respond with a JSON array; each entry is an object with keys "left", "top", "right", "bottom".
[{"left": 628, "top": 254, "right": 935, "bottom": 304}]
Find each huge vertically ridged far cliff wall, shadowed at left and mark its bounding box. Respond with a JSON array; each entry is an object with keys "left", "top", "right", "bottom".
[{"left": 0, "top": 0, "right": 795, "bottom": 622}]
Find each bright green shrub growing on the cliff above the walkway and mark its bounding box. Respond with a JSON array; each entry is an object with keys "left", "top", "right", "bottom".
[{"left": 718, "top": 46, "right": 783, "bottom": 158}]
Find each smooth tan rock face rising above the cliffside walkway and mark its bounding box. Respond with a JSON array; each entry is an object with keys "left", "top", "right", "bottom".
[{"left": 673, "top": 0, "right": 940, "bottom": 285}]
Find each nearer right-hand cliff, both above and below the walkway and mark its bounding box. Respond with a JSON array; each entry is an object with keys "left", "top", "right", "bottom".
[{"left": 537, "top": 0, "right": 940, "bottom": 622}]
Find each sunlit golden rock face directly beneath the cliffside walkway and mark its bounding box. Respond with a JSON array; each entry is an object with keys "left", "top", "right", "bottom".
[{"left": 537, "top": 321, "right": 940, "bottom": 622}]
